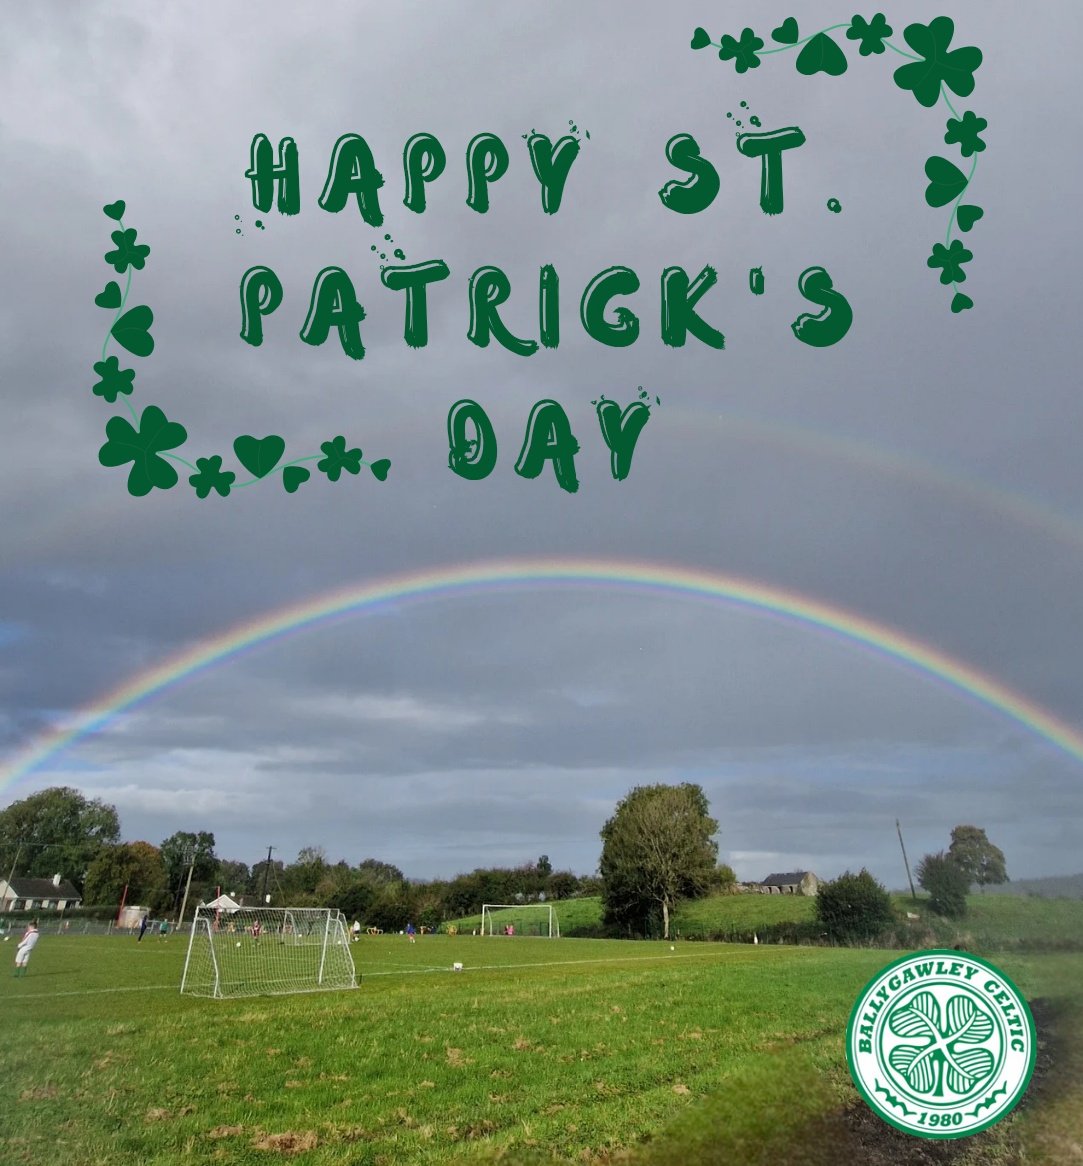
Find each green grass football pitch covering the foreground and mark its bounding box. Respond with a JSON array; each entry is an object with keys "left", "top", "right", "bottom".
[{"left": 0, "top": 934, "right": 1083, "bottom": 1166}]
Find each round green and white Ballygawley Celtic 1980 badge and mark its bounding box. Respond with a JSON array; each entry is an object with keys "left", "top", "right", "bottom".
[{"left": 846, "top": 950, "right": 1038, "bottom": 1138}]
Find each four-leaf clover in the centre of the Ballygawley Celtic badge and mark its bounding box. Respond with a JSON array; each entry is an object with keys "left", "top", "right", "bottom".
[{"left": 887, "top": 992, "right": 994, "bottom": 1097}]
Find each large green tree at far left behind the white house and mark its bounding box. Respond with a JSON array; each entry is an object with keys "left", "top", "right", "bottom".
[{"left": 0, "top": 786, "right": 120, "bottom": 887}]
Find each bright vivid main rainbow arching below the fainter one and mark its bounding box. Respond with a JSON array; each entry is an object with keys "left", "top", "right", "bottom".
[{"left": 0, "top": 559, "right": 1083, "bottom": 791}]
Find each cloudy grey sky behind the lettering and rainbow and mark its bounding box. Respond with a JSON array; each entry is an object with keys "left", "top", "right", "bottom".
[{"left": 0, "top": 0, "right": 1083, "bottom": 886}]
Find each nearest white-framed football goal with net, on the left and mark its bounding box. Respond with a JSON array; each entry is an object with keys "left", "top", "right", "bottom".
[{"left": 181, "top": 907, "right": 357, "bottom": 999}]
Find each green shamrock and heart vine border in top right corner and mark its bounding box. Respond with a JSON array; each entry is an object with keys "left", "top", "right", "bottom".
[{"left": 691, "top": 12, "right": 989, "bottom": 314}]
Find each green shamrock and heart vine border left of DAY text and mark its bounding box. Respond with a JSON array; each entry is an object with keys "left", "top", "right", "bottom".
[{"left": 92, "top": 199, "right": 391, "bottom": 498}]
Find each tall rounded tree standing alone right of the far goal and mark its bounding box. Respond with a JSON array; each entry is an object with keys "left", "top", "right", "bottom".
[{"left": 598, "top": 782, "right": 718, "bottom": 939}]
